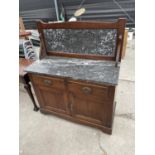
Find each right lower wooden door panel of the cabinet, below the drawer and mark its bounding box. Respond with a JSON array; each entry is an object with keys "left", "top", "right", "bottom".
[{"left": 69, "top": 93, "right": 106, "bottom": 125}]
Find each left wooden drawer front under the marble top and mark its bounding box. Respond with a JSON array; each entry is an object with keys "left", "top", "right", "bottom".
[{"left": 31, "top": 74, "right": 65, "bottom": 90}]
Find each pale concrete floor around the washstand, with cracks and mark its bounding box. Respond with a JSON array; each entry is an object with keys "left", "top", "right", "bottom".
[{"left": 19, "top": 40, "right": 135, "bottom": 155}]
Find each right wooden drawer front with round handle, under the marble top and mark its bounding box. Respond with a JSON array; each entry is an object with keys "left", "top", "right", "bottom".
[{"left": 68, "top": 81, "right": 112, "bottom": 101}]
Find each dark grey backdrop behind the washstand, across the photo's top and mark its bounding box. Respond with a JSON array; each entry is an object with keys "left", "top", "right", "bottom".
[{"left": 19, "top": 0, "right": 135, "bottom": 29}]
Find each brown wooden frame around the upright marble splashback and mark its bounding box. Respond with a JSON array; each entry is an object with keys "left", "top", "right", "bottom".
[{"left": 37, "top": 18, "right": 126, "bottom": 64}]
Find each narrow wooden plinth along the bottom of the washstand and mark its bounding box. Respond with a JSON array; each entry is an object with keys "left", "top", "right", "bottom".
[{"left": 40, "top": 108, "right": 112, "bottom": 135}]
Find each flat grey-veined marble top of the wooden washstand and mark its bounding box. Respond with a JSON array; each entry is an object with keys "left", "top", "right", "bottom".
[{"left": 25, "top": 57, "right": 120, "bottom": 85}]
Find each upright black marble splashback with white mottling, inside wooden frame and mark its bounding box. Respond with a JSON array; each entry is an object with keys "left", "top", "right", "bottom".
[{"left": 43, "top": 29, "right": 117, "bottom": 56}]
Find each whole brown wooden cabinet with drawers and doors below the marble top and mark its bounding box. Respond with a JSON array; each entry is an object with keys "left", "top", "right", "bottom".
[{"left": 30, "top": 74, "right": 115, "bottom": 134}]
